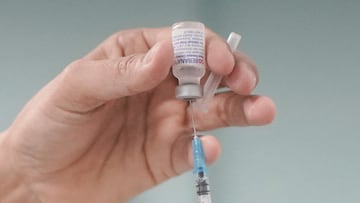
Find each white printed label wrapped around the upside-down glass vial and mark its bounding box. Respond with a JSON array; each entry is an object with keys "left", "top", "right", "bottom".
[{"left": 172, "top": 28, "right": 205, "bottom": 65}]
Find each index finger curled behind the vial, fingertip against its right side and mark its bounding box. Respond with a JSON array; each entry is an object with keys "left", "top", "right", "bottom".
[{"left": 84, "top": 27, "right": 235, "bottom": 72}]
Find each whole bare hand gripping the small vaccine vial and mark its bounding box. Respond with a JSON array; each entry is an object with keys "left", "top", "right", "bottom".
[{"left": 0, "top": 28, "right": 275, "bottom": 203}]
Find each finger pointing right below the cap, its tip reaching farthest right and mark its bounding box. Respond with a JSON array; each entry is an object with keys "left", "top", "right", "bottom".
[{"left": 188, "top": 92, "right": 276, "bottom": 131}]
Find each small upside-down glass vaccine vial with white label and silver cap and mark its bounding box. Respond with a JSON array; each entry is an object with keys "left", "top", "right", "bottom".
[{"left": 172, "top": 21, "right": 205, "bottom": 100}]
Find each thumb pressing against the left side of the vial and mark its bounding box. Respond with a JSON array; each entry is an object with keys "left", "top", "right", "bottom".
[{"left": 54, "top": 41, "right": 173, "bottom": 112}]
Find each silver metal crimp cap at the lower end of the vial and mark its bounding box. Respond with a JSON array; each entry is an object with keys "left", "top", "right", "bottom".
[{"left": 175, "top": 83, "right": 202, "bottom": 100}]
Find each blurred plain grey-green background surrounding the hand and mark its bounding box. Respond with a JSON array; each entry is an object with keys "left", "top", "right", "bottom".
[{"left": 0, "top": 0, "right": 360, "bottom": 203}]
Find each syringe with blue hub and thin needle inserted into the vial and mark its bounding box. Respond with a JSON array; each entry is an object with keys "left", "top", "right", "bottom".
[{"left": 189, "top": 100, "right": 211, "bottom": 203}]
